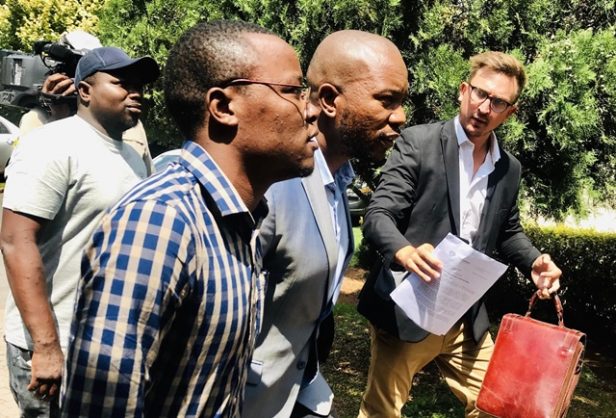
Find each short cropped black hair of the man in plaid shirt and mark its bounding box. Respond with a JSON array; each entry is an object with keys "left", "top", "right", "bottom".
[{"left": 164, "top": 20, "right": 273, "bottom": 139}]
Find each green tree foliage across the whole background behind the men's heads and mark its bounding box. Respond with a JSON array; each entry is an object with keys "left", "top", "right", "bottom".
[{"left": 0, "top": 0, "right": 616, "bottom": 218}]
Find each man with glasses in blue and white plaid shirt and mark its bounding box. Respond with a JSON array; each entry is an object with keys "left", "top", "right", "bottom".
[{"left": 62, "top": 21, "right": 316, "bottom": 417}]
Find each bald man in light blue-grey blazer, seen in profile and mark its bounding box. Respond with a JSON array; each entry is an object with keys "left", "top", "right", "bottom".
[{"left": 243, "top": 30, "right": 408, "bottom": 418}]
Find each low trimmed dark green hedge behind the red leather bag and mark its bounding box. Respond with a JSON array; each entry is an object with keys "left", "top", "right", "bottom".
[{"left": 357, "top": 225, "right": 616, "bottom": 344}]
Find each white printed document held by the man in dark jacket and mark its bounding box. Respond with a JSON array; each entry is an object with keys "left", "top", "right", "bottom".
[{"left": 391, "top": 234, "right": 507, "bottom": 335}]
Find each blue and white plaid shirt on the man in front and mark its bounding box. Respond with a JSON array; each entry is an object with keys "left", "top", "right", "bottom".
[{"left": 62, "top": 141, "right": 267, "bottom": 417}]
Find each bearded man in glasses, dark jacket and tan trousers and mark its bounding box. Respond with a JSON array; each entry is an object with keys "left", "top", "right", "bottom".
[{"left": 358, "top": 52, "right": 561, "bottom": 418}]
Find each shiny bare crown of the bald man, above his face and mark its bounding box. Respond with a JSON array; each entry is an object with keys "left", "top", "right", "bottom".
[{"left": 307, "top": 30, "right": 402, "bottom": 88}]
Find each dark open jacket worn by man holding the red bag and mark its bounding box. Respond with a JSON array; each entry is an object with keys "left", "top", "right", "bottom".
[{"left": 358, "top": 120, "right": 540, "bottom": 342}]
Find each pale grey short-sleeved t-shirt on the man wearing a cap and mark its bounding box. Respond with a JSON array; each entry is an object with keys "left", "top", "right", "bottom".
[{"left": 3, "top": 116, "right": 146, "bottom": 351}]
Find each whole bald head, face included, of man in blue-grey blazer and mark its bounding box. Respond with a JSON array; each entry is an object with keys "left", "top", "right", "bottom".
[{"left": 307, "top": 30, "right": 408, "bottom": 171}]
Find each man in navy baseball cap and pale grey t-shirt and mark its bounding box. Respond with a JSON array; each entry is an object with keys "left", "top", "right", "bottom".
[{"left": 0, "top": 47, "right": 159, "bottom": 417}]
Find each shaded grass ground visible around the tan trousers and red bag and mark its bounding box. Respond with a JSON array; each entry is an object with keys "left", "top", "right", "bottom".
[{"left": 324, "top": 269, "right": 616, "bottom": 418}]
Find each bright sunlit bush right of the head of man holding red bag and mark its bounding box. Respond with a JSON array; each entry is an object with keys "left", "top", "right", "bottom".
[{"left": 508, "top": 29, "right": 616, "bottom": 217}]
